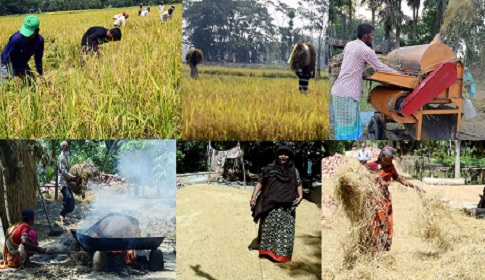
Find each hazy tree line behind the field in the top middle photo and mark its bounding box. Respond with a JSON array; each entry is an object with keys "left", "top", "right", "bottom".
[{"left": 183, "top": 0, "right": 328, "bottom": 64}]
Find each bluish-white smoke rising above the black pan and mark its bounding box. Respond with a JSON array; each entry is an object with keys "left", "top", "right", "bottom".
[{"left": 81, "top": 140, "right": 176, "bottom": 236}]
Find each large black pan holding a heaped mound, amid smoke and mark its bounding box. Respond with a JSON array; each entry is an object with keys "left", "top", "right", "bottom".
[{"left": 71, "top": 229, "right": 165, "bottom": 252}]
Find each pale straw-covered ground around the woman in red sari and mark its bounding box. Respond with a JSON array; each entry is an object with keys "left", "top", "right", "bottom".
[{"left": 322, "top": 179, "right": 485, "bottom": 280}]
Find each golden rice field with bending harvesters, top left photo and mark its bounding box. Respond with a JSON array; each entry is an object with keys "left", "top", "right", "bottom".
[{"left": 0, "top": 7, "right": 182, "bottom": 139}]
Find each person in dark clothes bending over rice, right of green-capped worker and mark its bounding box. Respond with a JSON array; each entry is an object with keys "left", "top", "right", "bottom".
[{"left": 81, "top": 26, "right": 121, "bottom": 55}]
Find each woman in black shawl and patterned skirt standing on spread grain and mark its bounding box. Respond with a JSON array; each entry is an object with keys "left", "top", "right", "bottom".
[{"left": 250, "top": 146, "right": 303, "bottom": 262}]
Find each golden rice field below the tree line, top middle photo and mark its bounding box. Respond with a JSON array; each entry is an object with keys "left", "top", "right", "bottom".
[{"left": 182, "top": 65, "right": 328, "bottom": 141}]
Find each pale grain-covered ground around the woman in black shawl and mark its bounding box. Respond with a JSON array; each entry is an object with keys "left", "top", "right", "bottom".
[{"left": 177, "top": 185, "right": 321, "bottom": 280}]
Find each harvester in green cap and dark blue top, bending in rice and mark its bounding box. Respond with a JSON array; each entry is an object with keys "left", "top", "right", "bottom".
[{"left": 0, "top": 15, "right": 44, "bottom": 85}]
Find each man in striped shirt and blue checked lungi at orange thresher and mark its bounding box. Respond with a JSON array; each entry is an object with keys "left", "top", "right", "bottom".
[{"left": 332, "top": 23, "right": 399, "bottom": 140}]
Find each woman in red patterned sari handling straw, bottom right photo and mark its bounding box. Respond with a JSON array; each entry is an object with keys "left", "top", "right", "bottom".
[{"left": 364, "top": 146, "right": 424, "bottom": 251}]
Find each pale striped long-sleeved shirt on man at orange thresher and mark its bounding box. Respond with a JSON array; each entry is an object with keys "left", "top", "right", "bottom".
[{"left": 332, "top": 39, "right": 399, "bottom": 102}]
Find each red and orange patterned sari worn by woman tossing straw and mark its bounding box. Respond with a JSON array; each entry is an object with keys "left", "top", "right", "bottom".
[{"left": 364, "top": 162, "right": 399, "bottom": 251}]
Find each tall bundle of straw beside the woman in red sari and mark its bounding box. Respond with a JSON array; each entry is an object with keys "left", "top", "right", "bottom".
[{"left": 335, "top": 162, "right": 384, "bottom": 252}]
